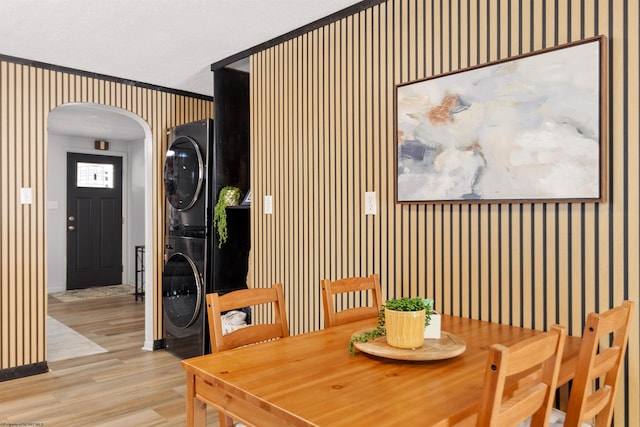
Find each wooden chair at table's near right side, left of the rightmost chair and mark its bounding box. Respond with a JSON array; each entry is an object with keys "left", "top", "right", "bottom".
[{"left": 476, "top": 325, "right": 566, "bottom": 426}]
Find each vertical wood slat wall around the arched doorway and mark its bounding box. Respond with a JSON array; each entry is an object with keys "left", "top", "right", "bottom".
[{"left": 0, "top": 60, "right": 213, "bottom": 370}]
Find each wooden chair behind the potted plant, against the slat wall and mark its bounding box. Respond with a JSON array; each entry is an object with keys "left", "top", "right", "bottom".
[{"left": 321, "top": 274, "right": 382, "bottom": 328}]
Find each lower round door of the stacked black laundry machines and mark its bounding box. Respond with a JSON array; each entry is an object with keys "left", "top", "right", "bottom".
[{"left": 162, "top": 252, "right": 202, "bottom": 328}]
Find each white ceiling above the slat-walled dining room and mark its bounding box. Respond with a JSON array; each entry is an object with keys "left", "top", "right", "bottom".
[{"left": 0, "top": 0, "right": 359, "bottom": 96}]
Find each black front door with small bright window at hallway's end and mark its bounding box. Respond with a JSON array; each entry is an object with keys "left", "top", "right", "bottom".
[{"left": 67, "top": 153, "right": 122, "bottom": 289}]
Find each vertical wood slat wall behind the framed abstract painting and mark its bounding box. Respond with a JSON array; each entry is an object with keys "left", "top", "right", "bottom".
[{"left": 250, "top": 0, "right": 640, "bottom": 426}]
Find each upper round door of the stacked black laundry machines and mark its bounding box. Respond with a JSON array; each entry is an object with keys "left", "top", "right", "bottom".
[{"left": 164, "top": 136, "right": 204, "bottom": 211}]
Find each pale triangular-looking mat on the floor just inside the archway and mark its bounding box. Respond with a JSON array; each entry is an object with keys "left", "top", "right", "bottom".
[{"left": 47, "top": 316, "right": 108, "bottom": 362}]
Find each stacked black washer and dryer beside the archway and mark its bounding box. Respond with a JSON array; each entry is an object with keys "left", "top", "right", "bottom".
[{"left": 162, "top": 120, "right": 213, "bottom": 358}]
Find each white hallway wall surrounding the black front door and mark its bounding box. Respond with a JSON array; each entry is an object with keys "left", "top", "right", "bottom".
[{"left": 46, "top": 134, "right": 145, "bottom": 293}]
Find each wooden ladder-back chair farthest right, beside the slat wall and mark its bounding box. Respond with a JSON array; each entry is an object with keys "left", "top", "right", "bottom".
[{"left": 552, "top": 301, "right": 634, "bottom": 427}]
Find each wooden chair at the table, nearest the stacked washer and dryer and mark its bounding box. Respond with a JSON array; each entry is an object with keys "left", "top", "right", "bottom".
[{"left": 206, "top": 283, "right": 289, "bottom": 427}]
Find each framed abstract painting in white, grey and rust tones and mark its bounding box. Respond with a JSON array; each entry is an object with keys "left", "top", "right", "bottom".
[{"left": 395, "top": 36, "right": 607, "bottom": 203}]
